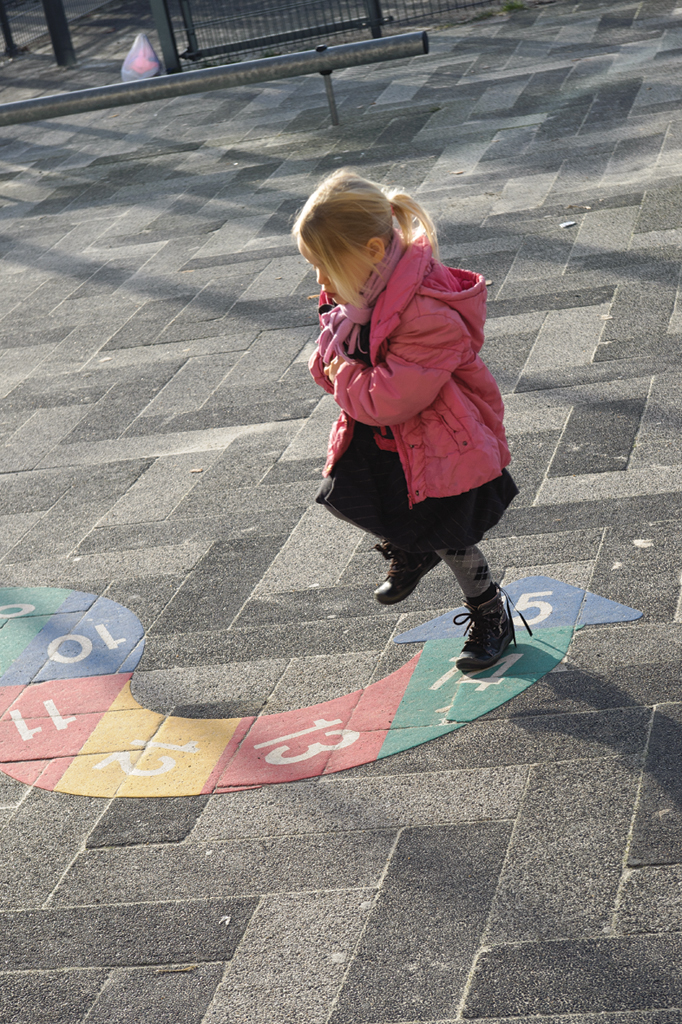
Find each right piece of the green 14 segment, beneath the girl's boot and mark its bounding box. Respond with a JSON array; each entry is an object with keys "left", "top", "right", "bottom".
[{"left": 444, "top": 626, "right": 573, "bottom": 722}]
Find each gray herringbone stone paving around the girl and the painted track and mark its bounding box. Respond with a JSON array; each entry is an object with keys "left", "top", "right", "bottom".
[{"left": 0, "top": 0, "right": 682, "bottom": 1024}]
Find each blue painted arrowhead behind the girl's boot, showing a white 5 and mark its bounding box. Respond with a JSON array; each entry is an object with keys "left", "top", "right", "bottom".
[{"left": 393, "top": 575, "right": 642, "bottom": 643}]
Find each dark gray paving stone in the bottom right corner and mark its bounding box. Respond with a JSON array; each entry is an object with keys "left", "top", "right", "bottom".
[{"left": 463, "top": 935, "right": 681, "bottom": 1019}]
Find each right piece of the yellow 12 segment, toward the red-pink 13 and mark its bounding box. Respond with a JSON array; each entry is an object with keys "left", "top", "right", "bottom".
[{"left": 117, "top": 718, "right": 241, "bottom": 797}]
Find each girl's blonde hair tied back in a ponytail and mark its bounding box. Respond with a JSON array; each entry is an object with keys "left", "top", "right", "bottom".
[{"left": 292, "top": 168, "right": 438, "bottom": 304}]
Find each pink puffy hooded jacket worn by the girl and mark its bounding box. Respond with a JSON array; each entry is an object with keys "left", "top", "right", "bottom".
[{"left": 309, "top": 237, "right": 511, "bottom": 506}]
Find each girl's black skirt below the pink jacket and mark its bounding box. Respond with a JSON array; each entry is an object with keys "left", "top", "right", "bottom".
[{"left": 315, "top": 423, "right": 518, "bottom": 553}]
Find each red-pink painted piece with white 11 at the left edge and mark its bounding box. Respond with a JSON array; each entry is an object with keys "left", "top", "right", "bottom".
[{"left": 0, "top": 673, "right": 132, "bottom": 770}]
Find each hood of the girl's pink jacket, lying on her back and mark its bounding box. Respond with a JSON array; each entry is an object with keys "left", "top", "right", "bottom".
[{"left": 370, "top": 234, "right": 487, "bottom": 360}]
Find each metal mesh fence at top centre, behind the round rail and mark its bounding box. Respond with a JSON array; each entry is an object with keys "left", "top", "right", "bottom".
[{"left": 167, "top": 0, "right": 495, "bottom": 68}]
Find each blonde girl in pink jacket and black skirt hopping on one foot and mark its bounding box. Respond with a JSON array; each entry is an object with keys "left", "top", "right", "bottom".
[{"left": 293, "top": 170, "right": 518, "bottom": 672}]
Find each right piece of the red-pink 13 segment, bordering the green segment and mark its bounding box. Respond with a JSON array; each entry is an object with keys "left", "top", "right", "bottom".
[{"left": 323, "top": 651, "right": 421, "bottom": 775}]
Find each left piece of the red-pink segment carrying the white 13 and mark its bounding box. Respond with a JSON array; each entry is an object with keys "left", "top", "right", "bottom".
[{"left": 217, "top": 690, "right": 363, "bottom": 790}]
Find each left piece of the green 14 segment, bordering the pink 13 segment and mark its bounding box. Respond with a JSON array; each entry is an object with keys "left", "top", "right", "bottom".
[{"left": 382, "top": 637, "right": 464, "bottom": 733}]
